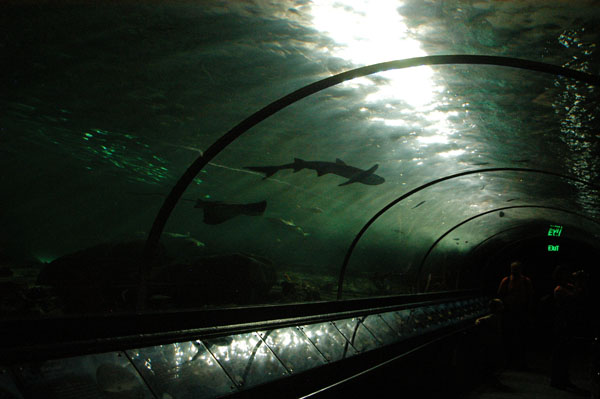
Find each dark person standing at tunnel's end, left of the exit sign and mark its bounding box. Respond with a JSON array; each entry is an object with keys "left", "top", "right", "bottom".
[{"left": 498, "top": 261, "right": 533, "bottom": 368}]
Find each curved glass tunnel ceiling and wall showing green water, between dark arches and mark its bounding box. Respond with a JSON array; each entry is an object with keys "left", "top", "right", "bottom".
[{"left": 0, "top": 0, "right": 600, "bottom": 317}]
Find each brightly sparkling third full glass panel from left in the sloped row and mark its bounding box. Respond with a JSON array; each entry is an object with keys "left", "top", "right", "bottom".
[{"left": 203, "top": 333, "right": 288, "bottom": 388}]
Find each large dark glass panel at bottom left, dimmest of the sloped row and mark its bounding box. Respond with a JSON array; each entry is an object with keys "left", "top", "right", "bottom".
[{"left": 17, "top": 352, "right": 154, "bottom": 399}]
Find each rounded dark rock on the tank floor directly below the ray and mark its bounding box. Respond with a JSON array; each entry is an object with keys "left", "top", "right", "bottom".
[{"left": 157, "top": 253, "right": 276, "bottom": 308}]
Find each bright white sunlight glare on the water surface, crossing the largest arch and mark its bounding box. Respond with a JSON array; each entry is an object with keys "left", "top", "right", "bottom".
[{"left": 310, "top": 0, "right": 465, "bottom": 158}]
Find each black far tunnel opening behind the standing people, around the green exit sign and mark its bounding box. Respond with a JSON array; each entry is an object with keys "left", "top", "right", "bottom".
[{"left": 478, "top": 228, "right": 600, "bottom": 344}]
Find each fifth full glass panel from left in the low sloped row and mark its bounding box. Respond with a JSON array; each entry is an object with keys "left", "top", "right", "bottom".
[{"left": 300, "top": 322, "right": 357, "bottom": 362}]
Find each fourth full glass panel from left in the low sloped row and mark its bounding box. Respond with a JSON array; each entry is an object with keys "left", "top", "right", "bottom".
[{"left": 259, "top": 327, "right": 326, "bottom": 373}]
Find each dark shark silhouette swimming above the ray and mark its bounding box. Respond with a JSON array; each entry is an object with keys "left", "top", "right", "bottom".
[{"left": 244, "top": 158, "right": 385, "bottom": 186}]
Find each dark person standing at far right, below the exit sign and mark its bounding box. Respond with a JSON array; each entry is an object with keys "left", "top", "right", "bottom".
[{"left": 550, "top": 266, "right": 579, "bottom": 389}]
